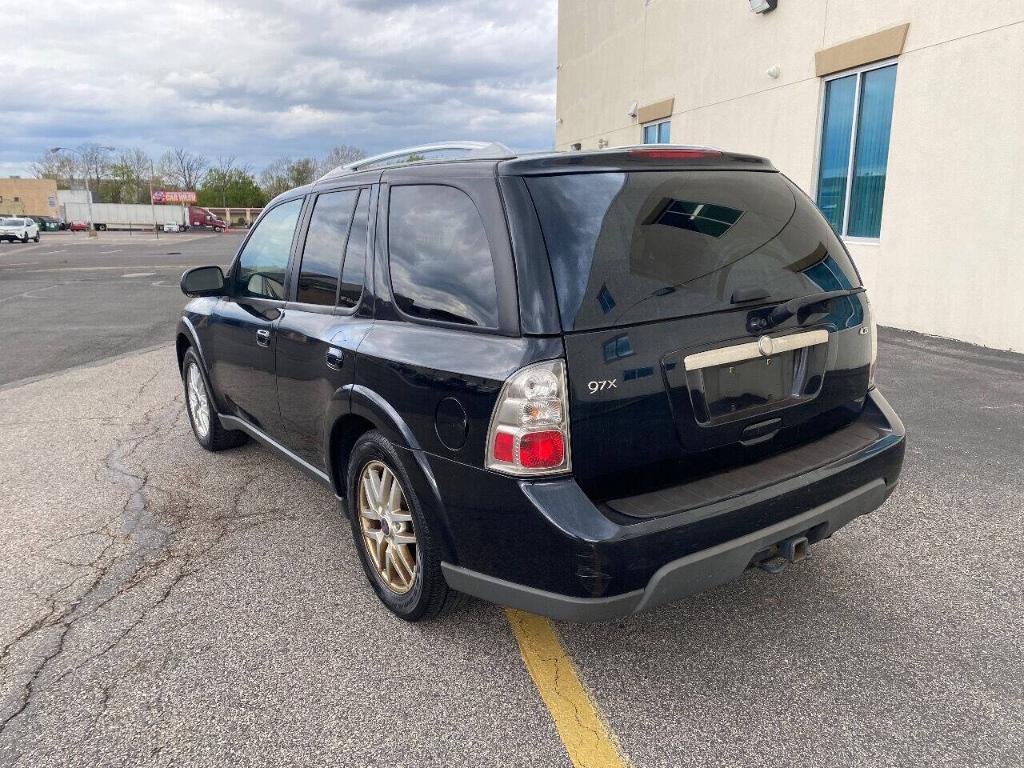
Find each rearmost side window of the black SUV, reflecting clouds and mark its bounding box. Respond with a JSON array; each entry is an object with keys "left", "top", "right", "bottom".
[{"left": 388, "top": 184, "right": 498, "bottom": 328}]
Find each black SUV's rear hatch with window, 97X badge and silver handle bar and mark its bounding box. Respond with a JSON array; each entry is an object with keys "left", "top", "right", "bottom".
[{"left": 526, "top": 168, "right": 871, "bottom": 508}]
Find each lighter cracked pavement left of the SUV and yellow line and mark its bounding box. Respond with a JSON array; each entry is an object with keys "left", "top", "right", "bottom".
[{"left": 0, "top": 347, "right": 568, "bottom": 766}]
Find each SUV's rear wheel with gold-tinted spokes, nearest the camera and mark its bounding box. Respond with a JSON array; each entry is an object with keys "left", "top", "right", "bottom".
[{"left": 346, "top": 430, "right": 462, "bottom": 622}]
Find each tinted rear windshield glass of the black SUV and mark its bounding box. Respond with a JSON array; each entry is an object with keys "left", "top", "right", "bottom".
[{"left": 526, "top": 171, "right": 860, "bottom": 331}]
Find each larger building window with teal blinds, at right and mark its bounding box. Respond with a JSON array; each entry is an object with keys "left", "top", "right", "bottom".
[{"left": 817, "top": 63, "right": 896, "bottom": 238}]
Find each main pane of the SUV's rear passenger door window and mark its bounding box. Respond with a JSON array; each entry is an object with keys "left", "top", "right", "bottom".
[{"left": 295, "top": 190, "right": 355, "bottom": 306}]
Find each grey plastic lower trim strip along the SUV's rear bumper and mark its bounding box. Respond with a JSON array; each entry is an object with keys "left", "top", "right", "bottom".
[{"left": 441, "top": 477, "right": 893, "bottom": 622}]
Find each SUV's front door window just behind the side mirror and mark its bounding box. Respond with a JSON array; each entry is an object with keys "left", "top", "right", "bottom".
[{"left": 234, "top": 198, "right": 302, "bottom": 299}]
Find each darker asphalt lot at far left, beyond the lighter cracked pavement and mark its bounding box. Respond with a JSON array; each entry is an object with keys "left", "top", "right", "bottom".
[{"left": 0, "top": 230, "right": 235, "bottom": 386}]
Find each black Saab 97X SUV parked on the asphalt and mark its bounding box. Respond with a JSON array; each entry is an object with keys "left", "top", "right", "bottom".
[{"left": 177, "top": 144, "right": 904, "bottom": 621}]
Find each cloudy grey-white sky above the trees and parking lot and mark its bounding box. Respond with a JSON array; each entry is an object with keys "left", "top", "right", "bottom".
[{"left": 0, "top": 0, "right": 557, "bottom": 176}]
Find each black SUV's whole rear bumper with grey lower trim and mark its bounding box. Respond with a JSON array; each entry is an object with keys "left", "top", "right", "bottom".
[{"left": 418, "top": 390, "right": 905, "bottom": 621}]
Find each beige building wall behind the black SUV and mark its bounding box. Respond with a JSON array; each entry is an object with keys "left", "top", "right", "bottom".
[{"left": 555, "top": 0, "right": 1024, "bottom": 351}]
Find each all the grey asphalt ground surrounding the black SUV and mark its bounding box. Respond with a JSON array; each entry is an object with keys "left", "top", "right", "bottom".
[{"left": 0, "top": 236, "right": 1024, "bottom": 768}]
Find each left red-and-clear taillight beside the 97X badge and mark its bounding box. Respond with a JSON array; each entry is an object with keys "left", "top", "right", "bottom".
[{"left": 487, "top": 359, "right": 571, "bottom": 475}]
